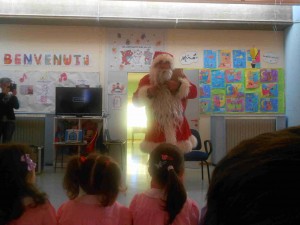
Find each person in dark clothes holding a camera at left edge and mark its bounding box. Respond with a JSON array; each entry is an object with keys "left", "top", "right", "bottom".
[{"left": 0, "top": 77, "right": 19, "bottom": 143}]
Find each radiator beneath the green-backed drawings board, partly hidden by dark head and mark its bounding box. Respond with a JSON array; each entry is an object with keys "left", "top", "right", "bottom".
[{"left": 225, "top": 118, "right": 276, "bottom": 151}]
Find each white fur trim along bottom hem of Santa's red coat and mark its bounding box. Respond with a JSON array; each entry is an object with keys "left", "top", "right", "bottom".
[{"left": 140, "top": 135, "right": 197, "bottom": 153}]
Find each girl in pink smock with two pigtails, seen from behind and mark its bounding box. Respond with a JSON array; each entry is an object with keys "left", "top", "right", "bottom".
[{"left": 57, "top": 153, "right": 132, "bottom": 225}]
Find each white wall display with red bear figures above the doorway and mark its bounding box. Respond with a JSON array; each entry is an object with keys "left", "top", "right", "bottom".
[{"left": 108, "top": 28, "right": 164, "bottom": 71}]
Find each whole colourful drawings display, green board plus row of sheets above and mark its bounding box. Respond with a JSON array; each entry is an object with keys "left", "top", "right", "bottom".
[{"left": 199, "top": 50, "right": 285, "bottom": 114}]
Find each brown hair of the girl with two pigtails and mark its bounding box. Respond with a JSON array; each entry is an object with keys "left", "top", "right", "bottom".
[{"left": 64, "top": 153, "right": 121, "bottom": 206}]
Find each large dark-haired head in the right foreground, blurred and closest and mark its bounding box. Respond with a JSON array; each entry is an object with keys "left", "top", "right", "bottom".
[{"left": 201, "top": 126, "right": 300, "bottom": 225}]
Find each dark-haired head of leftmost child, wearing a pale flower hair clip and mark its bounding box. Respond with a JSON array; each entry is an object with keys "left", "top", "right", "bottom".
[{"left": 0, "top": 144, "right": 46, "bottom": 222}]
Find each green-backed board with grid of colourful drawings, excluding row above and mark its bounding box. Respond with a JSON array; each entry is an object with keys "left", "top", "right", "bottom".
[{"left": 199, "top": 68, "right": 285, "bottom": 114}]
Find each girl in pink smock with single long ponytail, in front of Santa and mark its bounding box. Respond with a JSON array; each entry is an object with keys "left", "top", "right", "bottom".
[{"left": 129, "top": 143, "right": 199, "bottom": 225}]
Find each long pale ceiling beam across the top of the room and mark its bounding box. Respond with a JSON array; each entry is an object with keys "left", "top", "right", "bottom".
[{"left": 0, "top": 0, "right": 296, "bottom": 30}]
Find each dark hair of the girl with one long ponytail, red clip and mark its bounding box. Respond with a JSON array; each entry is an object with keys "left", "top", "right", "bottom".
[{"left": 149, "top": 143, "right": 187, "bottom": 224}]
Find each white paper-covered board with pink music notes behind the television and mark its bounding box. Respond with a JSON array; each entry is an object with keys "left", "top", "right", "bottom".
[{"left": 0, "top": 70, "right": 100, "bottom": 114}]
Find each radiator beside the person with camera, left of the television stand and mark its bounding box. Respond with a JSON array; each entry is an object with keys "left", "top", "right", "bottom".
[{"left": 12, "top": 117, "right": 45, "bottom": 146}]
